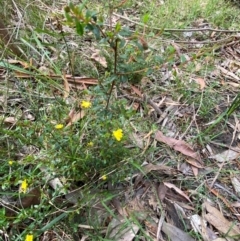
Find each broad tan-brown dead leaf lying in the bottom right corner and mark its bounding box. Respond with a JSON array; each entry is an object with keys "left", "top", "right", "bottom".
[{"left": 203, "top": 202, "right": 240, "bottom": 237}]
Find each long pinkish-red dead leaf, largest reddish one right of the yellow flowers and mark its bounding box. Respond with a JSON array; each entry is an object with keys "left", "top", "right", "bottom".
[{"left": 155, "top": 131, "right": 202, "bottom": 164}]
